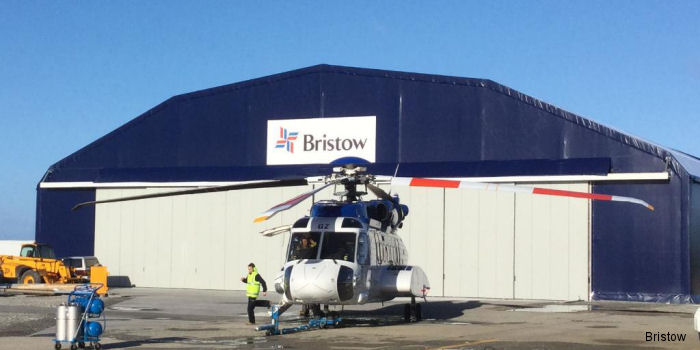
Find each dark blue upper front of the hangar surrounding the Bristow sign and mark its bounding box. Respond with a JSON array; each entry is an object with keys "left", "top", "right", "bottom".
[{"left": 42, "top": 65, "right": 700, "bottom": 182}]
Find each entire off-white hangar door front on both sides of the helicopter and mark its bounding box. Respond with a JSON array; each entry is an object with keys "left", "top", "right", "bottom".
[{"left": 95, "top": 184, "right": 589, "bottom": 300}]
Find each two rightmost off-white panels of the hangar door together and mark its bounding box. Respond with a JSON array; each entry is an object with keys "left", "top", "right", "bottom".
[{"left": 442, "top": 183, "right": 590, "bottom": 300}]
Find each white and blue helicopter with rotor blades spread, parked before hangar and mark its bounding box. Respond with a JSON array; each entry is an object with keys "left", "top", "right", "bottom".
[{"left": 73, "top": 164, "right": 654, "bottom": 322}]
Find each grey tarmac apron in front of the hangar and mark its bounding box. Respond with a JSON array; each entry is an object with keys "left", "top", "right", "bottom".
[{"left": 0, "top": 288, "right": 700, "bottom": 350}]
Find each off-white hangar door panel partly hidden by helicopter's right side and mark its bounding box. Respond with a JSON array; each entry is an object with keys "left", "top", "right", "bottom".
[{"left": 392, "top": 187, "right": 444, "bottom": 296}]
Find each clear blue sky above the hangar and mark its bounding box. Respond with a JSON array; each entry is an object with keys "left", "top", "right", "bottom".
[{"left": 0, "top": 0, "right": 700, "bottom": 239}]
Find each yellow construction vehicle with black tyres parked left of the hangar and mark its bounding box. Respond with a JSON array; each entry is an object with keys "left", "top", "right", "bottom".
[{"left": 0, "top": 243, "right": 84, "bottom": 284}]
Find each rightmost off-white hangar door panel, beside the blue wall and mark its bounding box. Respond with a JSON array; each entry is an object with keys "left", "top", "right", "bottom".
[{"left": 515, "top": 184, "right": 589, "bottom": 300}]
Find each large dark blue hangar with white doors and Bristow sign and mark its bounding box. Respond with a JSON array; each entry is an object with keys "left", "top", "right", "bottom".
[{"left": 36, "top": 65, "right": 700, "bottom": 303}]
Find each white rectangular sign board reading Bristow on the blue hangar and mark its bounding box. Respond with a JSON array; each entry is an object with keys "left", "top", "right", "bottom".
[{"left": 266, "top": 116, "right": 377, "bottom": 165}]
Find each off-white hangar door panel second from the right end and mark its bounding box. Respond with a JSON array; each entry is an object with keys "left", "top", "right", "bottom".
[{"left": 445, "top": 189, "right": 514, "bottom": 298}]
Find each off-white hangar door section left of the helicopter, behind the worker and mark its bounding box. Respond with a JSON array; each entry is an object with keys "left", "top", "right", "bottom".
[{"left": 95, "top": 186, "right": 311, "bottom": 290}]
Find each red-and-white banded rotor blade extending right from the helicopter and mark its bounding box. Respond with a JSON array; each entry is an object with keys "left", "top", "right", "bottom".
[{"left": 391, "top": 177, "right": 654, "bottom": 210}]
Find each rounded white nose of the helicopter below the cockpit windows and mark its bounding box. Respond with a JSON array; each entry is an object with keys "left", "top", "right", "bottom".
[{"left": 285, "top": 260, "right": 353, "bottom": 304}]
